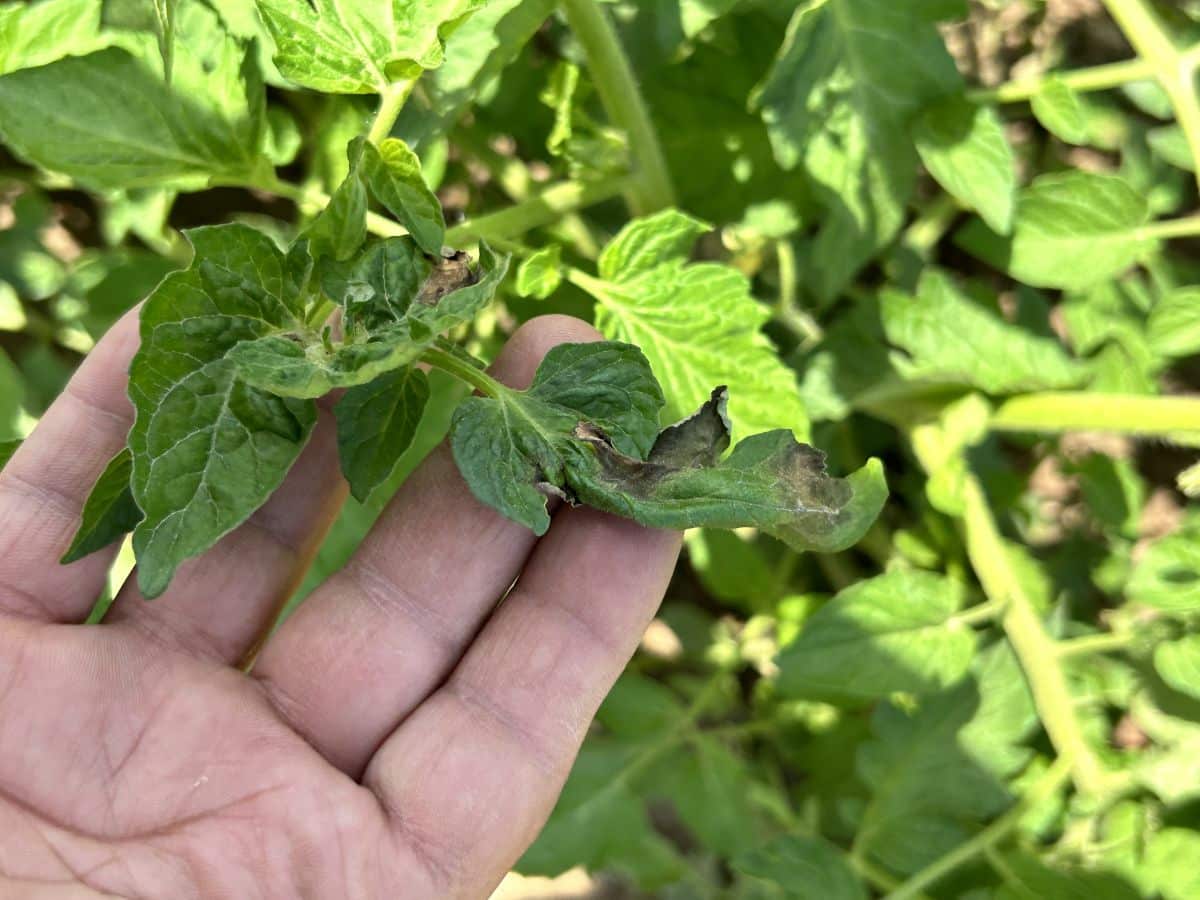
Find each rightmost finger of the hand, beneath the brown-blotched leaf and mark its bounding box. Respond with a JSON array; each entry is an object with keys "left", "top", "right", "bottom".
[{"left": 364, "top": 509, "right": 679, "bottom": 896}]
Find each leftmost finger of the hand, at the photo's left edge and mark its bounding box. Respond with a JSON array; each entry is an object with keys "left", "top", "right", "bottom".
[{"left": 0, "top": 310, "right": 138, "bottom": 622}]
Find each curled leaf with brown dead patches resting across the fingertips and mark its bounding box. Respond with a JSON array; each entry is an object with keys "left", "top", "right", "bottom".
[{"left": 451, "top": 343, "right": 887, "bottom": 551}]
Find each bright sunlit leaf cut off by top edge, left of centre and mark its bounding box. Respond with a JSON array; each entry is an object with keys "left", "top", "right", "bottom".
[{"left": 257, "top": 0, "right": 484, "bottom": 94}]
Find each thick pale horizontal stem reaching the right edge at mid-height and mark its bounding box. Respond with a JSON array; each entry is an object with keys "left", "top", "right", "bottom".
[{"left": 990, "top": 391, "right": 1200, "bottom": 436}]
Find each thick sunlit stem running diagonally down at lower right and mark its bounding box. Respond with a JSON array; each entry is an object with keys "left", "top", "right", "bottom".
[{"left": 965, "top": 474, "right": 1106, "bottom": 794}]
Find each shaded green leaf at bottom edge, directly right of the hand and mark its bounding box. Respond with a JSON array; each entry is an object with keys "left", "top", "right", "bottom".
[{"left": 516, "top": 742, "right": 684, "bottom": 889}]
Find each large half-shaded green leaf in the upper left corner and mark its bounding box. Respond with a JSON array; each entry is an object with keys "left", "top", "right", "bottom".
[{"left": 0, "top": 4, "right": 265, "bottom": 191}]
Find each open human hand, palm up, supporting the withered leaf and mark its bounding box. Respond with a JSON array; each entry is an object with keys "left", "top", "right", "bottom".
[{"left": 0, "top": 313, "right": 679, "bottom": 900}]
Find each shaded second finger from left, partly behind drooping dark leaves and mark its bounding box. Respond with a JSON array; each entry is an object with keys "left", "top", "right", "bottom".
[{"left": 104, "top": 401, "right": 347, "bottom": 664}]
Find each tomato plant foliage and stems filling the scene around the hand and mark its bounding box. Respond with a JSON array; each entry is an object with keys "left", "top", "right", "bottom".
[{"left": 0, "top": 0, "right": 1200, "bottom": 900}]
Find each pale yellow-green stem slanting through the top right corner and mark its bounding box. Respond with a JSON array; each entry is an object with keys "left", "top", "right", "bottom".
[{"left": 1104, "top": 0, "right": 1200, "bottom": 187}]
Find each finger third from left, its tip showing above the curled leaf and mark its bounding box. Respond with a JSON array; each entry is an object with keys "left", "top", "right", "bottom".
[{"left": 253, "top": 316, "right": 598, "bottom": 778}]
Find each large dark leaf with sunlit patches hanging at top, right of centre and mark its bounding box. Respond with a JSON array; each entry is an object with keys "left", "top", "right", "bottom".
[{"left": 756, "top": 0, "right": 960, "bottom": 301}]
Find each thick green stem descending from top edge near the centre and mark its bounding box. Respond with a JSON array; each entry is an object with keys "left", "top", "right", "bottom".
[{"left": 563, "top": 0, "right": 674, "bottom": 216}]
